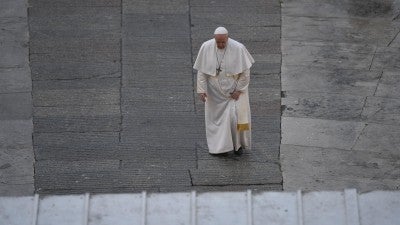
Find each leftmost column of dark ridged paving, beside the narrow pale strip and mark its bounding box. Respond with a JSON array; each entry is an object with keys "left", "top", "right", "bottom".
[{"left": 29, "top": 0, "right": 122, "bottom": 192}]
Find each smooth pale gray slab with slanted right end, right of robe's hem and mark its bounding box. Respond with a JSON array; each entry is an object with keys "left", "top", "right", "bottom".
[{"left": 281, "top": 117, "right": 365, "bottom": 150}]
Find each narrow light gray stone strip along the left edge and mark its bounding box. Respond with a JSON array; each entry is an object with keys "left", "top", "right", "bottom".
[{"left": 0, "top": 0, "right": 34, "bottom": 195}]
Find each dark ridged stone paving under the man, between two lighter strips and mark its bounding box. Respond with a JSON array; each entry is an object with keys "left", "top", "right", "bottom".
[{"left": 24, "top": 0, "right": 282, "bottom": 193}]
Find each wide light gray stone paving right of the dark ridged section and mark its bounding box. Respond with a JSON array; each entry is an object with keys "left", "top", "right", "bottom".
[{"left": 280, "top": 0, "right": 400, "bottom": 191}]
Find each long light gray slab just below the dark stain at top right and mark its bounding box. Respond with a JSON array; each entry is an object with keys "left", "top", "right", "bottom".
[{"left": 282, "top": 16, "right": 397, "bottom": 46}]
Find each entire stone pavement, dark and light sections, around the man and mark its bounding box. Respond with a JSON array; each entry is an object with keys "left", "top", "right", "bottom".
[{"left": 0, "top": 0, "right": 400, "bottom": 195}]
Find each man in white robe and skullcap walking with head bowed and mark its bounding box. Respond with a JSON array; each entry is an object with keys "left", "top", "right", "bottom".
[{"left": 193, "top": 27, "right": 254, "bottom": 155}]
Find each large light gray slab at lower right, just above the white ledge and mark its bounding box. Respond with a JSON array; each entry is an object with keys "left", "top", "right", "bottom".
[{"left": 281, "top": 144, "right": 400, "bottom": 191}]
